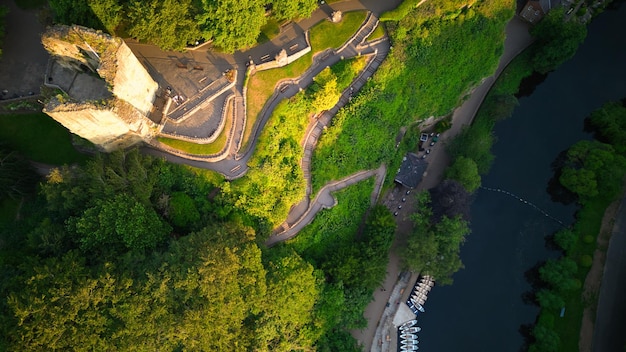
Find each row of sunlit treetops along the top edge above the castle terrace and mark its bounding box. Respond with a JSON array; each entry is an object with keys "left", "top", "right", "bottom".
[{"left": 49, "top": 0, "right": 317, "bottom": 52}]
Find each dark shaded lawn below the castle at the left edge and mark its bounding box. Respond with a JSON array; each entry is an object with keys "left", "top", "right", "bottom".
[{"left": 0, "top": 113, "right": 87, "bottom": 165}]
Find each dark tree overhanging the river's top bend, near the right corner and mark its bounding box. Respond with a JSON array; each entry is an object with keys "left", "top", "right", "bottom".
[{"left": 531, "top": 7, "right": 587, "bottom": 73}]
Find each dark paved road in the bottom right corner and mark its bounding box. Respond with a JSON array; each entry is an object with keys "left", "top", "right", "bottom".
[{"left": 592, "top": 194, "right": 626, "bottom": 352}]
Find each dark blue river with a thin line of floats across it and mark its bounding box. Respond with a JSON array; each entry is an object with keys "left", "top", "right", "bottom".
[{"left": 419, "top": 2, "right": 626, "bottom": 352}]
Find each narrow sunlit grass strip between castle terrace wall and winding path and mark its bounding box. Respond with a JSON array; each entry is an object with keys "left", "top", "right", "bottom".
[{"left": 242, "top": 11, "right": 366, "bottom": 150}]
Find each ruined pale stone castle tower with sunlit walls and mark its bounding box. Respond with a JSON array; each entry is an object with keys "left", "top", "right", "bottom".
[{"left": 42, "top": 25, "right": 159, "bottom": 151}]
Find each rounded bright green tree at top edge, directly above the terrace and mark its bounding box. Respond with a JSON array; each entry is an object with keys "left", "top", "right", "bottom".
[{"left": 196, "top": 0, "right": 267, "bottom": 53}]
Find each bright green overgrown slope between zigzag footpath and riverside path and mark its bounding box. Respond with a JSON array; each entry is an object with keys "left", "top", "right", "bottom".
[{"left": 312, "top": 0, "right": 513, "bottom": 190}]
